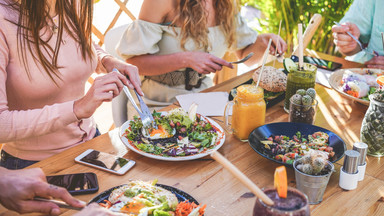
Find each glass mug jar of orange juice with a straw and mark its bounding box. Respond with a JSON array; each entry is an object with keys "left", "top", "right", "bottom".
[{"left": 224, "top": 85, "right": 266, "bottom": 142}]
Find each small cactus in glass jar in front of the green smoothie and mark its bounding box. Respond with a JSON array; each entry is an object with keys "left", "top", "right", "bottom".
[{"left": 289, "top": 88, "right": 317, "bottom": 124}]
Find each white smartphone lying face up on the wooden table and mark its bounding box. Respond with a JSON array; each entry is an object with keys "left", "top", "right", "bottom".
[{"left": 75, "top": 149, "right": 136, "bottom": 175}]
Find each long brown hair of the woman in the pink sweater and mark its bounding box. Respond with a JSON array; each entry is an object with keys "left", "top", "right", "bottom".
[{"left": 3, "top": 0, "right": 94, "bottom": 84}]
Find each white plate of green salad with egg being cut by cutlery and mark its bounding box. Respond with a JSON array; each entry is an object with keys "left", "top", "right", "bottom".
[{"left": 120, "top": 108, "right": 225, "bottom": 161}]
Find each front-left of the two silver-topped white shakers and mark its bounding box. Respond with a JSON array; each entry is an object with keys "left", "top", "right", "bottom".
[{"left": 339, "top": 150, "right": 360, "bottom": 190}]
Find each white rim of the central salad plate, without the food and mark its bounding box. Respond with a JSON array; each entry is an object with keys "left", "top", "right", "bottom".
[{"left": 119, "top": 113, "right": 225, "bottom": 161}]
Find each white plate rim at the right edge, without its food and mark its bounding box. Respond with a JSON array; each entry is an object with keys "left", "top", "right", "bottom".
[{"left": 329, "top": 68, "right": 383, "bottom": 106}]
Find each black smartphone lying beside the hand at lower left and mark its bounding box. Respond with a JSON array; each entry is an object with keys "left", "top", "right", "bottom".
[{"left": 47, "top": 173, "right": 99, "bottom": 195}]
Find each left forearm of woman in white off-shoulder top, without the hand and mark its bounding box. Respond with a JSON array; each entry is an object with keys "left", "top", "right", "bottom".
[{"left": 127, "top": 52, "right": 191, "bottom": 76}]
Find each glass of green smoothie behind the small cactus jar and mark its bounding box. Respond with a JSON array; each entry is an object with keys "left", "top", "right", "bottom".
[{"left": 284, "top": 63, "right": 317, "bottom": 113}]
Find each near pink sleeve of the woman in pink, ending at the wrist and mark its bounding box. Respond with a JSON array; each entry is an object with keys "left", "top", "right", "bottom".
[{"left": 0, "top": 18, "right": 77, "bottom": 142}]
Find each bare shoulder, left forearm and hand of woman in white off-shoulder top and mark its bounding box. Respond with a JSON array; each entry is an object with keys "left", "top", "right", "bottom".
[{"left": 117, "top": 0, "right": 232, "bottom": 76}]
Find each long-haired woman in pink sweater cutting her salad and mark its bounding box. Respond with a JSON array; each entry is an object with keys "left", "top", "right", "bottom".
[{"left": 0, "top": 0, "right": 142, "bottom": 169}]
